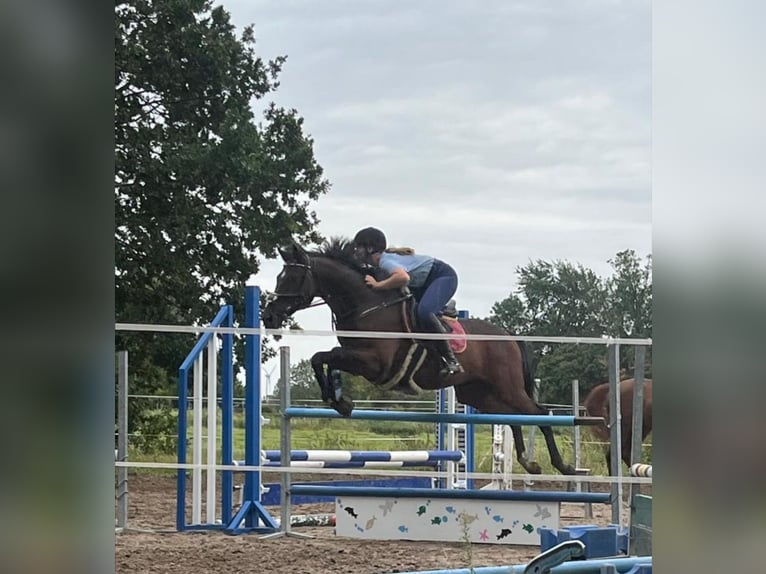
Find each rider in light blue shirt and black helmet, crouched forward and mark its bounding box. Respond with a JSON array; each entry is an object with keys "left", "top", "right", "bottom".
[{"left": 354, "top": 227, "right": 462, "bottom": 375}]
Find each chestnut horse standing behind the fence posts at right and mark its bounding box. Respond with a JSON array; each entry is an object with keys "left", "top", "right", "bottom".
[{"left": 583, "top": 379, "right": 652, "bottom": 472}]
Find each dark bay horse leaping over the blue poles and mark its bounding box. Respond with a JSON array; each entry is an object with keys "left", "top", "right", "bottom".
[{"left": 262, "top": 239, "right": 574, "bottom": 474}]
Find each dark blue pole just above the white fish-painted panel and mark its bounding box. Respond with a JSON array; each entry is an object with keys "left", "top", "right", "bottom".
[{"left": 290, "top": 484, "right": 611, "bottom": 504}]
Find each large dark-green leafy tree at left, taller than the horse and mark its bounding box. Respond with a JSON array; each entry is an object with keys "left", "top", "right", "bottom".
[{"left": 114, "top": 0, "right": 329, "bottom": 446}]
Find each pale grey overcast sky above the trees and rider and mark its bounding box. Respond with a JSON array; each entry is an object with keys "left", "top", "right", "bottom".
[{"left": 223, "top": 0, "right": 651, "bottom": 394}]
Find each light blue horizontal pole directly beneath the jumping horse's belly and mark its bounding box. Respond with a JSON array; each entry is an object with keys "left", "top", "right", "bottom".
[{"left": 285, "top": 407, "right": 604, "bottom": 427}]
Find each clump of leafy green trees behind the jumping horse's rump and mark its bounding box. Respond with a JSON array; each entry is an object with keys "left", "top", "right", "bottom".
[{"left": 489, "top": 254, "right": 651, "bottom": 403}]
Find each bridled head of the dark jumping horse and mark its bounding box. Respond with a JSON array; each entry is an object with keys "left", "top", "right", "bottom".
[{"left": 261, "top": 242, "right": 316, "bottom": 329}]
